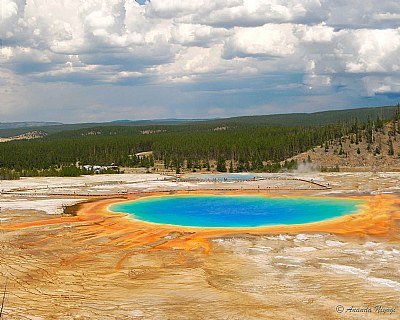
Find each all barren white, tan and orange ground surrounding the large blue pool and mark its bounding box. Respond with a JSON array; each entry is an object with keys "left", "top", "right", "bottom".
[{"left": 0, "top": 173, "right": 400, "bottom": 320}]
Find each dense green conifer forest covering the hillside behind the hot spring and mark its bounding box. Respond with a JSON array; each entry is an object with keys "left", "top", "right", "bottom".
[{"left": 0, "top": 106, "right": 400, "bottom": 178}]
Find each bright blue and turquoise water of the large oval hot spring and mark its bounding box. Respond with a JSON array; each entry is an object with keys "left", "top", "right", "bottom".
[{"left": 110, "top": 195, "right": 364, "bottom": 227}]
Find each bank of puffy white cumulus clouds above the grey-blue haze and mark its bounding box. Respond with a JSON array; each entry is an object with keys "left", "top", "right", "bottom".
[{"left": 0, "top": 0, "right": 400, "bottom": 120}]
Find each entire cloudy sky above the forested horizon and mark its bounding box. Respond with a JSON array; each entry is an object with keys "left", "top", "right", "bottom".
[{"left": 0, "top": 0, "right": 400, "bottom": 123}]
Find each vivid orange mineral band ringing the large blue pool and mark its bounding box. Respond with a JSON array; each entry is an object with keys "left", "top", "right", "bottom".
[{"left": 0, "top": 191, "right": 400, "bottom": 258}]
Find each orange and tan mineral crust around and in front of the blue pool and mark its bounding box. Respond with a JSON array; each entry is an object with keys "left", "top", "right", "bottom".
[{"left": 0, "top": 191, "right": 400, "bottom": 320}]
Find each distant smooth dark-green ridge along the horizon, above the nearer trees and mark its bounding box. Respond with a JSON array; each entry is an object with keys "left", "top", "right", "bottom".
[{"left": 0, "top": 106, "right": 396, "bottom": 138}]
